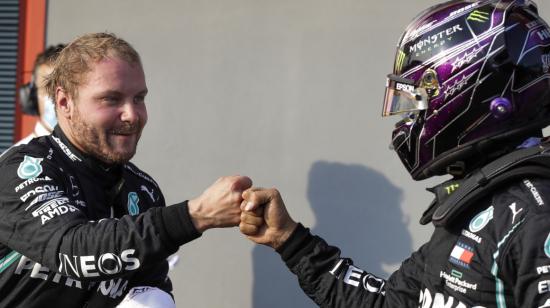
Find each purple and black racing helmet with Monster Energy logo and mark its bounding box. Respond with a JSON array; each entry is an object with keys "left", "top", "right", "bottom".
[{"left": 383, "top": 0, "right": 550, "bottom": 180}]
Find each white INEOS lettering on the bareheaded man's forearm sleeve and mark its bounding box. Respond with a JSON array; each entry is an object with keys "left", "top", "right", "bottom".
[{"left": 59, "top": 249, "right": 141, "bottom": 278}]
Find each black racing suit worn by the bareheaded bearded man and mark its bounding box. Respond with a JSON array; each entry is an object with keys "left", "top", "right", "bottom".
[{"left": 0, "top": 127, "right": 200, "bottom": 307}]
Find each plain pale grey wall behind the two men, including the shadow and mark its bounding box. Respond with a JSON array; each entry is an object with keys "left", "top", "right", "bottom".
[{"left": 47, "top": 0, "right": 550, "bottom": 308}]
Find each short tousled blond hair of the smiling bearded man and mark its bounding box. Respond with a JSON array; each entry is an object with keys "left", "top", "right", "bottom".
[{"left": 45, "top": 32, "right": 141, "bottom": 99}]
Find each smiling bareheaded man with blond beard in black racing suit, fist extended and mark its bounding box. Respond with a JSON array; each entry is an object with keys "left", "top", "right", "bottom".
[{"left": 0, "top": 33, "right": 252, "bottom": 307}]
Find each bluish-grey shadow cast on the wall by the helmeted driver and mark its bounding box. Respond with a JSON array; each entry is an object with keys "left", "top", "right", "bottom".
[{"left": 253, "top": 161, "right": 412, "bottom": 308}]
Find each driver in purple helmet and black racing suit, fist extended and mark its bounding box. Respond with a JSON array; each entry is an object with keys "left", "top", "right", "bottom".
[{"left": 240, "top": 0, "right": 550, "bottom": 308}]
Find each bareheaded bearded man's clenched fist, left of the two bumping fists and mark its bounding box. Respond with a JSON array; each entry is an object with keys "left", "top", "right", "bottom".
[{"left": 188, "top": 176, "right": 252, "bottom": 233}]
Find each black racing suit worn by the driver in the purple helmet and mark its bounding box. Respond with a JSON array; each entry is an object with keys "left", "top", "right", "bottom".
[{"left": 278, "top": 173, "right": 550, "bottom": 308}]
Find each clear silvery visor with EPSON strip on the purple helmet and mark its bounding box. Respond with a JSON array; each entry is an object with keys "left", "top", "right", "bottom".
[{"left": 382, "top": 74, "right": 428, "bottom": 117}]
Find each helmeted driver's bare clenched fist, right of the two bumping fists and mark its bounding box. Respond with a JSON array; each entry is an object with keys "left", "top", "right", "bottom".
[{"left": 239, "top": 188, "right": 298, "bottom": 249}]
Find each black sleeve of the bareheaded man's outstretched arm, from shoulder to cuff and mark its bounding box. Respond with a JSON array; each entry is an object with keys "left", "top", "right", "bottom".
[{"left": 0, "top": 155, "right": 200, "bottom": 281}]
